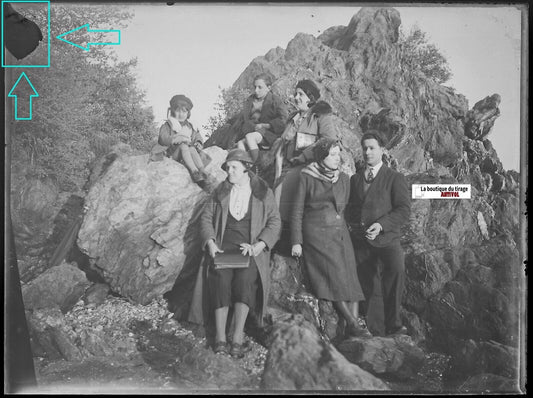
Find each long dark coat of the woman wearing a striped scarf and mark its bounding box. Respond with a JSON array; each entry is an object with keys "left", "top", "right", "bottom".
[{"left": 291, "top": 173, "right": 364, "bottom": 301}]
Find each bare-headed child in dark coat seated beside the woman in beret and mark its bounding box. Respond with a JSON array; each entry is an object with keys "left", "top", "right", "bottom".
[{"left": 237, "top": 73, "right": 288, "bottom": 163}]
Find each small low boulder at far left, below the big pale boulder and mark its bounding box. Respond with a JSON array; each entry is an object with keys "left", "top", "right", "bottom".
[{"left": 22, "top": 263, "right": 91, "bottom": 312}]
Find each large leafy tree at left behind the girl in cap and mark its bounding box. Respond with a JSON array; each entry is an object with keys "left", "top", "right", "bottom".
[{"left": 8, "top": 4, "right": 154, "bottom": 191}]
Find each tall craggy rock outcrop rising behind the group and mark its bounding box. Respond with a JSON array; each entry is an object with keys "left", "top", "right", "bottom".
[{"left": 206, "top": 4, "right": 523, "bottom": 380}]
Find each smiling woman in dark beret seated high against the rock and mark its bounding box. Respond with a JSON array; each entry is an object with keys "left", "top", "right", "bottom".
[{"left": 274, "top": 80, "right": 338, "bottom": 255}]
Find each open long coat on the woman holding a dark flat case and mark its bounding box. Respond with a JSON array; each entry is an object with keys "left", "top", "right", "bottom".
[{"left": 187, "top": 174, "right": 281, "bottom": 325}]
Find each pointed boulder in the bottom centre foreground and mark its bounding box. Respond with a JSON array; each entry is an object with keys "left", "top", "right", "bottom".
[{"left": 262, "top": 315, "right": 389, "bottom": 391}]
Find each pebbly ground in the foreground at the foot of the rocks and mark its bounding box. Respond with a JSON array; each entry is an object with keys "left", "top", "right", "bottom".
[{"left": 23, "top": 296, "right": 462, "bottom": 393}]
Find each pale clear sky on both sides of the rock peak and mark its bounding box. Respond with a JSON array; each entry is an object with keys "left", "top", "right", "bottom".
[{"left": 112, "top": 3, "right": 521, "bottom": 171}]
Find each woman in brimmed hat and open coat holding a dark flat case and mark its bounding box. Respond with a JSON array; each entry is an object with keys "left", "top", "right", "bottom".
[{"left": 195, "top": 148, "right": 280, "bottom": 357}]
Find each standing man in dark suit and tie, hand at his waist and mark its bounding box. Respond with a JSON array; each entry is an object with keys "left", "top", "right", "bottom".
[{"left": 347, "top": 130, "right": 411, "bottom": 335}]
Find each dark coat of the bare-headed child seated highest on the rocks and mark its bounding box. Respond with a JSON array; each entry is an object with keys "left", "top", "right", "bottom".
[{"left": 239, "top": 91, "right": 289, "bottom": 145}]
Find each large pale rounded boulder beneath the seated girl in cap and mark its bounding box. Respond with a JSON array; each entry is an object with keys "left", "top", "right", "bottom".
[{"left": 78, "top": 147, "right": 226, "bottom": 304}]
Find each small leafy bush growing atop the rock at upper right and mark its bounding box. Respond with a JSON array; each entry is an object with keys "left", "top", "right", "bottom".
[{"left": 400, "top": 26, "right": 452, "bottom": 84}]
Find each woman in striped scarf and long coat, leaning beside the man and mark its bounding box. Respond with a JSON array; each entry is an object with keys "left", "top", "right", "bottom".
[{"left": 291, "top": 138, "right": 371, "bottom": 337}]
